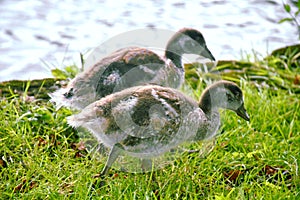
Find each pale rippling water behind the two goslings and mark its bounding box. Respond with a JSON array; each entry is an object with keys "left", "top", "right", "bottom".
[{"left": 0, "top": 0, "right": 298, "bottom": 81}]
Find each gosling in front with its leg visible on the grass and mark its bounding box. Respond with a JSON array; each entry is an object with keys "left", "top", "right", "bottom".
[{"left": 68, "top": 81, "right": 250, "bottom": 176}]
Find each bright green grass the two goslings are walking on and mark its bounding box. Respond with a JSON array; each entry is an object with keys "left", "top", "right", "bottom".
[{"left": 0, "top": 46, "right": 300, "bottom": 199}]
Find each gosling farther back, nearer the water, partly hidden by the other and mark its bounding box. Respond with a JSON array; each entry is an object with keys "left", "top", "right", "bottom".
[{"left": 50, "top": 28, "right": 215, "bottom": 109}]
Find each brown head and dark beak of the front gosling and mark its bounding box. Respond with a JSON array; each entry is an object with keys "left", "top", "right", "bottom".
[{"left": 199, "top": 81, "right": 250, "bottom": 121}]
